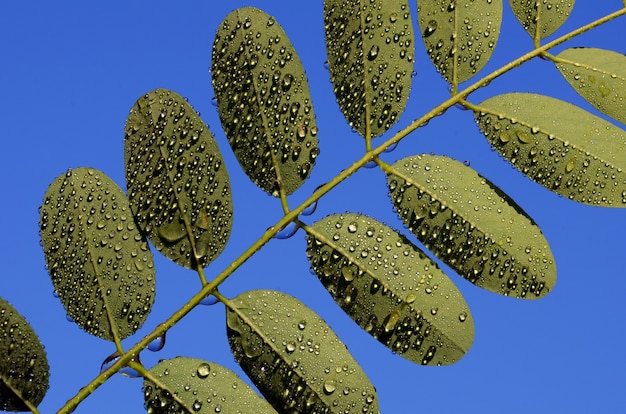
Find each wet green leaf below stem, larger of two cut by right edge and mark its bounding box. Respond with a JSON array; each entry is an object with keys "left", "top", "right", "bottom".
[{"left": 474, "top": 93, "right": 626, "bottom": 207}]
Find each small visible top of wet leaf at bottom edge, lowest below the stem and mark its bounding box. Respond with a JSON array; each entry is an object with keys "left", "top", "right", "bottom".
[{"left": 143, "top": 357, "right": 276, "bottom": 414}]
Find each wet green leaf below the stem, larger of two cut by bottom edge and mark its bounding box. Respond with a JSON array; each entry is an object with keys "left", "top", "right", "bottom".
[{"left": 226, "top": 290, "right": 379, "bottom": 413}]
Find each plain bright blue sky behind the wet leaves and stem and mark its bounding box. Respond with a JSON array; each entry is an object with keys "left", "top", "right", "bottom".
[{"left": 0, "top": 0, "right": 626, "bottom": 413}]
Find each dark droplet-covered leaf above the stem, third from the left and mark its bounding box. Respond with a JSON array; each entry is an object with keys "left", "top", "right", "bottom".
[{"left": 124, "top": 89, "right": 233, "bottom": 269}]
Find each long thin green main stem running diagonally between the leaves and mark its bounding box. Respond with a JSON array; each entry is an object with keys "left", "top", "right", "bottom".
[{"left": 58, "top": 7, "right": 626, "bottom": 413}]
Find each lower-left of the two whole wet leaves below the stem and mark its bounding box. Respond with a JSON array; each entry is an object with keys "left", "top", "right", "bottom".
[{"left": 307, "top": 213, "right": 474, "bottom": 365}]
